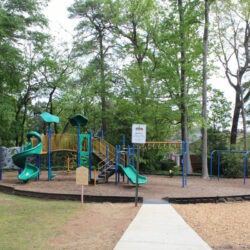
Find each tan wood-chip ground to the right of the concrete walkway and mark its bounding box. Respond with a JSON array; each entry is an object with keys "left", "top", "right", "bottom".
[{"left": 173, "top": 202, "right": 250, "bottom": 249}]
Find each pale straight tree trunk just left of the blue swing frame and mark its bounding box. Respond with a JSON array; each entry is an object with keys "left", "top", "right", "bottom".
[{"left": 201, "top": 0, "right": 209, "bottom": 178}]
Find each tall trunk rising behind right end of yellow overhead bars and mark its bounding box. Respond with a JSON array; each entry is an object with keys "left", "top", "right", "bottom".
[{"left": 178, "top": 0, "right": 193, "bottom": 173}]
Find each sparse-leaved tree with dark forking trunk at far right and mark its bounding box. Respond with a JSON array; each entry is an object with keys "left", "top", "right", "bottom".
[{"left": 215, "top": 0, "right": 250, "bottom": 149}]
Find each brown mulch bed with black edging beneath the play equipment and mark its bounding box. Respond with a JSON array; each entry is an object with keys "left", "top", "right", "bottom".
[{"left": 0, "top": 171, "right": 250, "bottom": 203}]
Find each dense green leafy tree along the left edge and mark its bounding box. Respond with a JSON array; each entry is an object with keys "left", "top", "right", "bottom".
[{"left": 0, "top": 0, "right": 47, "bottom": 144}]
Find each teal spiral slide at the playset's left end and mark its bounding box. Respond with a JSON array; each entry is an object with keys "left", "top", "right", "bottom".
[{"left": 12, "top": 131, "right": 42, "bottom": 182}]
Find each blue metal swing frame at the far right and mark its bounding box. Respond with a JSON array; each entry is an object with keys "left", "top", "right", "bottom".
[{"left": 210, "top": 150, "right": 249, "bottom": 184}]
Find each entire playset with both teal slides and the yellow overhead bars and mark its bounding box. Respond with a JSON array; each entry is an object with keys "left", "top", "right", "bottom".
[{"left": 1, "top": 112, "right": 191, "bottom": 187}]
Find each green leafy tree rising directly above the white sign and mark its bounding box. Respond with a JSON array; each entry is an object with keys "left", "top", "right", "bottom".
[{"left": 110, "top": 0, "right": 156, "bottom": 122}]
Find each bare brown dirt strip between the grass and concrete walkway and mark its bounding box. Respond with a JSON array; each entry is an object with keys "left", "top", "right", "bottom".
[{"left": 50, "top": 203, "right": 139, "bottom": 250}]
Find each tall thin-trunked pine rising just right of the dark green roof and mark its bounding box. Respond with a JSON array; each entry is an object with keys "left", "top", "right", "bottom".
[{"left": 69, "top": 0, "right": 112, "bottom": 135}]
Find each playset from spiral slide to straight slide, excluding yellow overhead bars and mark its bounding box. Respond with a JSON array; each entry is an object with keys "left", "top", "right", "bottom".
[{"left": 5, "top": 112, "right": 147, "bottom": 184}]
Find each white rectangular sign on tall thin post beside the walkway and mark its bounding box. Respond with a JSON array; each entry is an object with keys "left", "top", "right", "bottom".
[{"left": 132, "top": 124, "right": 146, "bottom": 207}]
